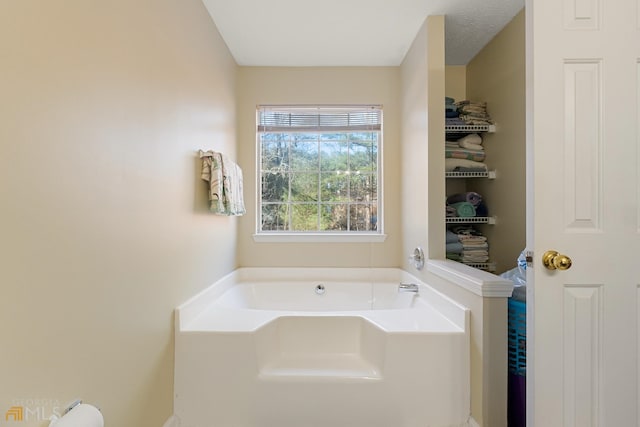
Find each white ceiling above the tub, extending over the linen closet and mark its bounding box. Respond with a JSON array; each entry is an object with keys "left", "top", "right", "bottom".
[{"left": 203, "top": 0, "right": 524, "bottom": 66}]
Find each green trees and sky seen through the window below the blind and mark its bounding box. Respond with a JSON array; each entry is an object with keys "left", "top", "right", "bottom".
[{"left": 258, "top": 108, "right": 381, "bottom": 233}]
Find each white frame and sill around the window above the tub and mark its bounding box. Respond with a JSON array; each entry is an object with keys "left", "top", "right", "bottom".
[{"left": 253, "top": 104, "right": 386, "bottom": 243}]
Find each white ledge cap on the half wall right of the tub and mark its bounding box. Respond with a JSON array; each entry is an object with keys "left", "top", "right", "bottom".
[{"left": 427, "top": 259, "right": 513, "bottom": 298}]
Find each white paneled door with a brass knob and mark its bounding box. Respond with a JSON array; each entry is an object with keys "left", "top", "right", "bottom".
[{"left": 526, "top": 0, "right": 640, "bottom": 427}]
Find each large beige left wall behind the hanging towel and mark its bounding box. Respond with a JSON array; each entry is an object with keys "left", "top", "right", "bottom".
[{"left": 0, "top": 0, "right": 238, "bottom": 427}]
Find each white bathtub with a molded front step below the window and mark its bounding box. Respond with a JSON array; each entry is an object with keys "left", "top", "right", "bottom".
[{"left": 174, "top": 268, "right": 470, "bottom": 427}]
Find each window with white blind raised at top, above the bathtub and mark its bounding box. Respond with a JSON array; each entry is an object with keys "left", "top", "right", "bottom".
[{"left": 257, "top": 106, "right": 382, "bottom": 235}]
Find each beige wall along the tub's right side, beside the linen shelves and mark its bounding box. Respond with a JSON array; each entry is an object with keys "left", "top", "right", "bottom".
[{"left": 401, "top": 16, "right": 496, "bottom": 425}]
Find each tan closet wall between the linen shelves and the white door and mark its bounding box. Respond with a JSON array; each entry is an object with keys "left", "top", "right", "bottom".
[{"left": 466, "top": 10, "right": 526, "bottom": 273}]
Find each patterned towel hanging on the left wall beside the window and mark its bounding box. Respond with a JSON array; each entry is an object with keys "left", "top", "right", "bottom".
[{"left": 198, "top": 150, "right": 246, "bottom": 215}]
